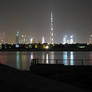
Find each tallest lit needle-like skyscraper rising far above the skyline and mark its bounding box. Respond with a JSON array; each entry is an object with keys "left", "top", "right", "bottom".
[{"left": 50, "top": 11, "right": 54, "bottom": 44}]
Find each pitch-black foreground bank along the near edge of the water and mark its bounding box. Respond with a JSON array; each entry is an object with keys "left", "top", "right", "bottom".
[{"left": 0, "top": 65, "right": 92, "bottom": 92}]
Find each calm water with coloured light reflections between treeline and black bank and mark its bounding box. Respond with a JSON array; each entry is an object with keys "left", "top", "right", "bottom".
[{"left": 0, "top": 52, "right": 92, "bottom": 70}]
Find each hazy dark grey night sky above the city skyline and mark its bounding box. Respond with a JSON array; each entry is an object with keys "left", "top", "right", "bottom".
[{"left": 0, "top": 0, "right": 92, "bottom": 42}]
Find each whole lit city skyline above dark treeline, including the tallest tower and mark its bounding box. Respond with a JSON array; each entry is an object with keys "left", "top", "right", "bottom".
[{"left": 0, "top": 12, "right": 92, "bottom": 44}]
